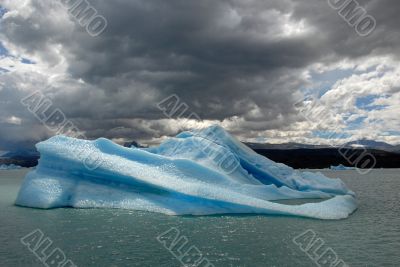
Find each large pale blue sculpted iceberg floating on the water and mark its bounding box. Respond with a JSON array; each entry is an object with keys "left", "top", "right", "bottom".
[{"left": 16, "top": 126, "right": 357, "bottom": 219}]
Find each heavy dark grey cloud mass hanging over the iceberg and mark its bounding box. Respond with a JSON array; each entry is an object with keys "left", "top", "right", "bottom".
[{"left": 1, "top": 0, "right": 400, "bottom": 149}]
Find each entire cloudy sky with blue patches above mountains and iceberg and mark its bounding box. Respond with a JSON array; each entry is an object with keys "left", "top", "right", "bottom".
[{"left": 0, "top": 0, "right": 400, "bottom": 150}]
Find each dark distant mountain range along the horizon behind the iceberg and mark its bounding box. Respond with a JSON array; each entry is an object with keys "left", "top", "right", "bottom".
[{"left": 0, "top": 139, "right": 400, "bottom": 169}]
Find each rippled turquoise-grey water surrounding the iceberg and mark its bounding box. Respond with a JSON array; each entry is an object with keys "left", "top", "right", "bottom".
[{"left": 0, "top": 170, "right": 400, "bottom": 267}]
